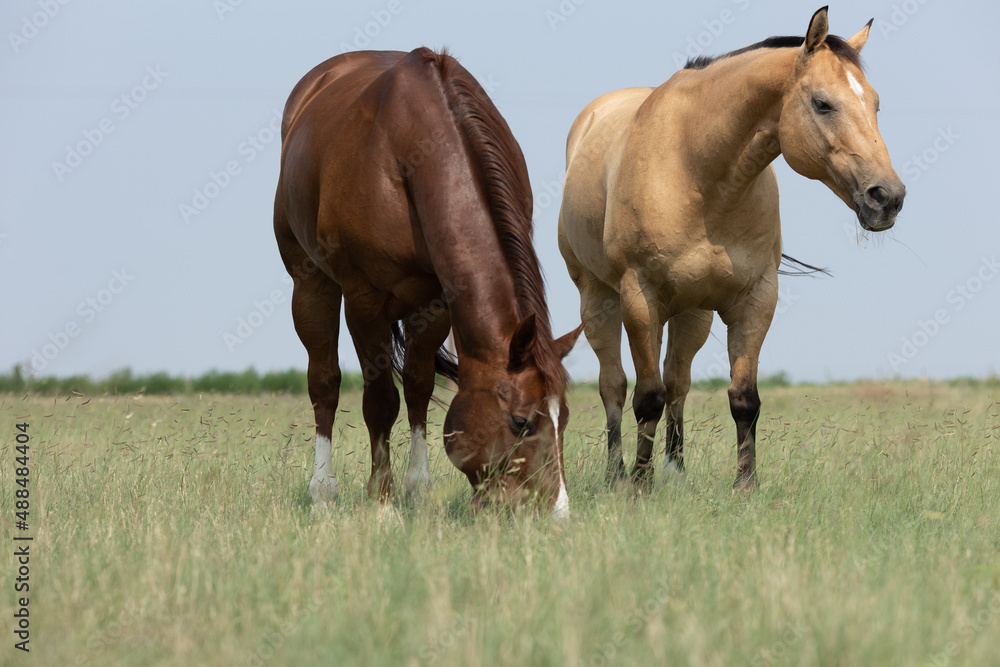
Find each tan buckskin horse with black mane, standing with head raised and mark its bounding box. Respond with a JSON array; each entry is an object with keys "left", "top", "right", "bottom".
[{"left": 559, "top": 7, "right": 905, "bottom": 488}]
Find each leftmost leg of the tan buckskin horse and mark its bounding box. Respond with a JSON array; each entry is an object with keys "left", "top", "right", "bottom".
[{"left": 578, "top": 272, "right": 628, "bottom": 484}]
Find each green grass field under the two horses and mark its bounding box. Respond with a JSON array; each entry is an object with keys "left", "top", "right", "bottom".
[{"left": 0, "top": 382, "right": 1000, "bottom": 666}]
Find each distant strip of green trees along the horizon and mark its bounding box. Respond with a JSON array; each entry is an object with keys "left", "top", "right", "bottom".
[{"left": 0, "top": 366, "right": 1000, "bottom": 396}]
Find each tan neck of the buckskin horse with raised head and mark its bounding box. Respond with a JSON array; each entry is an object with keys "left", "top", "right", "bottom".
[{"left": 685, "top": 48, "right": 798, "bottom": 205}]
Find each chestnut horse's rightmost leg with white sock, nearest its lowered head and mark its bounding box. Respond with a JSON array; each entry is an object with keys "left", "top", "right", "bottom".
[{"left": 403, "top": 308, "right": 451, "bottom": 500}]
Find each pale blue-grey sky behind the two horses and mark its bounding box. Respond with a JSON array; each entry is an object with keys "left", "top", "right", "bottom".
[{"left": 0, "top": 0, "right": 1000, "bottom": 381}]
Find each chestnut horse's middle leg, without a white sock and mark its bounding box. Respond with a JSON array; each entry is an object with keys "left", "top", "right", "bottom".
[{"left": 345, "top": 308, "right": 399, "bottom": 505}]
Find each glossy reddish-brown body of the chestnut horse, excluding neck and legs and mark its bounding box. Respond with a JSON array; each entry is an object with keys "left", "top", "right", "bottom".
[{"left": 275, "top": 49, "right": 460, "bottom": 314}]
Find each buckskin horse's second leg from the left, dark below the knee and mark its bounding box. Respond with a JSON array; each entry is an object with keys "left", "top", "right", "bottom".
[{"left": 620, "top": 269, "right": 667, "bottom": 486}]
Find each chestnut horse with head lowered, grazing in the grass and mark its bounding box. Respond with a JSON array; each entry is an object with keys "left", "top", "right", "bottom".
[{"left": 274, "top": 48, "right": 582, "bottom": 515}]
